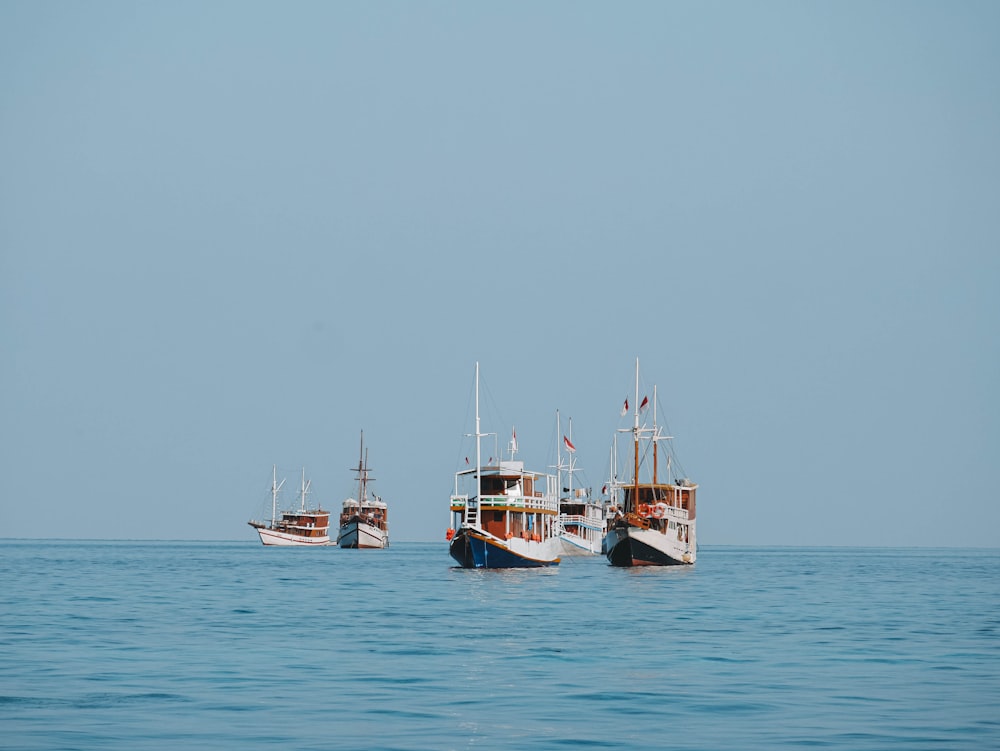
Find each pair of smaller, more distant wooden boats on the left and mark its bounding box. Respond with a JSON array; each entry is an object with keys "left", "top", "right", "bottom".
[{"left": 247, "top": 433, "right": 389, "bottom": 549}]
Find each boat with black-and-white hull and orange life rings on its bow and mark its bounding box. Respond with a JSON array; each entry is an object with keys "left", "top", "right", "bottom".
[{"left": 604, "top": 358, "right": 698, "bottom": 566}]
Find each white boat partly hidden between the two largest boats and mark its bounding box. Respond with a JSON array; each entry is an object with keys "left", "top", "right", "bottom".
[{"left": 556, "top": 411, "right": 607, "bottom": 556}]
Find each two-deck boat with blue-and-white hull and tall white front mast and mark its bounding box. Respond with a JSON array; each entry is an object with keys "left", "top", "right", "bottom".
[{"left": 445, "top": 362, "right": 560, "bottom": 569}]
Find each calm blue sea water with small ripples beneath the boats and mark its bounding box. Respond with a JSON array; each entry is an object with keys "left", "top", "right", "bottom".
[{"left": 0, "top": 541, "right": 1000, "bottom": 751}]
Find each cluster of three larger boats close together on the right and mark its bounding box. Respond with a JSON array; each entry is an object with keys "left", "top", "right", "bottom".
[{"left": 446, "top": 360, "right": 698, "bottom": 568}]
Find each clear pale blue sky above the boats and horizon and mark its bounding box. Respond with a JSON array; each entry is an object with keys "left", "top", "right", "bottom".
[{"left": 0, "top": 0, "right": 1000, "bottom": 547}]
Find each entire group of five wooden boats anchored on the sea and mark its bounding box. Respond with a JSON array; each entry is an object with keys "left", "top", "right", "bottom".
[{"left": 249, "top": 360, "right": 698, "bottom": 568}]
